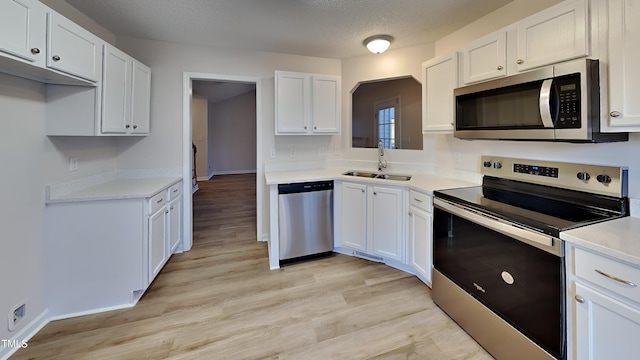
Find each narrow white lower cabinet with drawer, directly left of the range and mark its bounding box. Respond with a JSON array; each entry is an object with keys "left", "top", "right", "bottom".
[{"left": 407, "top": 190, "right": 433, "bottom": 286}]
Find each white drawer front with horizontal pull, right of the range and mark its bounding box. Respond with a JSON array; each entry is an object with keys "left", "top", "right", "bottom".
[{"left": 574, "top": 248, "right": 640, "bottom": 303}]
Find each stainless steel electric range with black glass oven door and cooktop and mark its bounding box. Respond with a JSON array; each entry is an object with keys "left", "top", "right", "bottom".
[{"left": 432, "top": 156, "right": 629, "bottom": 359}]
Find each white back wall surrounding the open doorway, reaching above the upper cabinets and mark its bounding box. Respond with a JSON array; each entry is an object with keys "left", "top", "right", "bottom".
[{"left": 110, "top": 38, "right": 340, "bottom": 242}]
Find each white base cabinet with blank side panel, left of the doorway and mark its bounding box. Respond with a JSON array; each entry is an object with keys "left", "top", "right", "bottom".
[{"left": 44, "top": 182, "right": 182, "bottom": 318}]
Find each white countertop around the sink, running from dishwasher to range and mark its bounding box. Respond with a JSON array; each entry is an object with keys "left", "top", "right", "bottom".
[{"left": 265, "top": 168, "right": 479, "bottom": 194}]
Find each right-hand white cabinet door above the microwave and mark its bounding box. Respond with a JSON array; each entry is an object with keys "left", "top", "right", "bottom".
[{"left": 516, "top": 0, "right": 588, "bottom": 71}]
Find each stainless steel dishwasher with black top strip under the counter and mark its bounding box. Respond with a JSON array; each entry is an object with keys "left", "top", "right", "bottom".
[{"left": 278, "top": 181, "right": 333, "bottom": 264}]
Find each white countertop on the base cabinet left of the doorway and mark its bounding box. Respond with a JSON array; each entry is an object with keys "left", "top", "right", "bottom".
[{"left": 45, "top": 177, "right": 181, "bottom": 204}]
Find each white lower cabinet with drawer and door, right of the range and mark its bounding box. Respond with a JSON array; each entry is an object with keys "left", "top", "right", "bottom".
[{"left": 567, "top": 246, "right": 640, "bottom": 360}]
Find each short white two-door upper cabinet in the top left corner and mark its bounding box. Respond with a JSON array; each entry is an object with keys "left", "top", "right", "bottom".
[{"left": 0, "top": 0, "right": 104, "bottom": 86}]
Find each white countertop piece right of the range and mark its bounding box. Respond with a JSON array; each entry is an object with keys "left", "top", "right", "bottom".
[{"left": 560, "top": 216, "right": 640, "bottom": 266}]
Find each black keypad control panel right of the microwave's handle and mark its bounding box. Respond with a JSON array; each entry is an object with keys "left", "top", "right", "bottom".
[{"left": 555, "top": 74, "right": 580, "bottom": 129}]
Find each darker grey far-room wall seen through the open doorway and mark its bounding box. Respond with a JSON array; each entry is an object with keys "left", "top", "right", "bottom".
[{"left": 209, "top": 91, "right": 256, "bottom": 175}]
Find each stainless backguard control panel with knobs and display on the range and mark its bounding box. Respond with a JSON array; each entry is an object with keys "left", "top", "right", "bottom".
[{"left": 481, "top": 155, "right": 628, "bottom": 197}]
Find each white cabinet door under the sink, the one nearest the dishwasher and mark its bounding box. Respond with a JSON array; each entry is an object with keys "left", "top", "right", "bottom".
[{"left": 340, "top": 182, "right": 367, "bottom": 251}]
